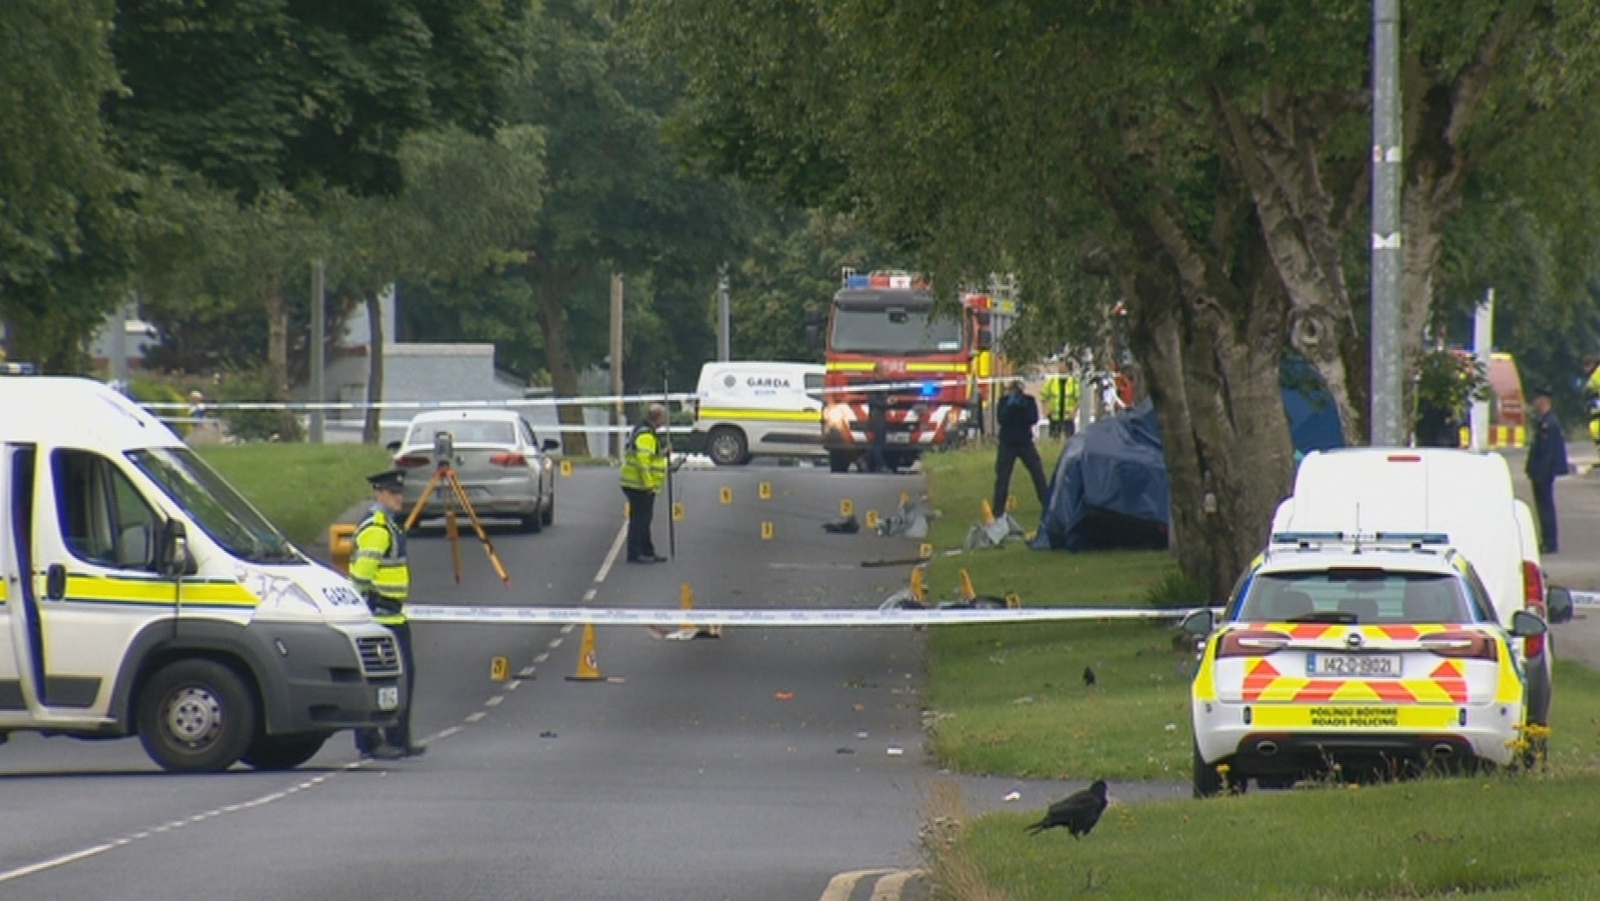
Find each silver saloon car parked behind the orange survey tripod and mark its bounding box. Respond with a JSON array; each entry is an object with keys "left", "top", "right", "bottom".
[{"left": 395, "top": 410, "right": 560, "bottom": 531}]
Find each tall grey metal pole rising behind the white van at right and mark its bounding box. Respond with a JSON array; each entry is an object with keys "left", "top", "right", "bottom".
[{"left": 1371, "top": 0, "right": 1405, "bottom": 446}]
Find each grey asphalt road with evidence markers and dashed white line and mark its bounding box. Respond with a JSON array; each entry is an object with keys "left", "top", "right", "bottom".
[{"left": 0, "top": 466, "right": 1139, "bottom": 901}]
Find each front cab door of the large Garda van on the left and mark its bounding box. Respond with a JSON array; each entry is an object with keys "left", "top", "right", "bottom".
[{"left": 29, "top": 448, "right": 178, "bottom": 715}]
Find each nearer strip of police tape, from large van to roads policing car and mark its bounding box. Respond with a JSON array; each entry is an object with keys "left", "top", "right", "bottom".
[{"left": 405, "top": 605, "right": 1190, "bottom": 627}]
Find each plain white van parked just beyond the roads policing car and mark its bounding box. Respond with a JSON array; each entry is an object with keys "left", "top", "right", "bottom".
[{"left": 1272, "top": 448, "right": 1571, "bottom": 725}]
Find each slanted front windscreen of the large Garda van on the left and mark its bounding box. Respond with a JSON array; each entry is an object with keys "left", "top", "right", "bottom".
[{"left": 128, "top": 448, "right": 306, "bottom": 563}]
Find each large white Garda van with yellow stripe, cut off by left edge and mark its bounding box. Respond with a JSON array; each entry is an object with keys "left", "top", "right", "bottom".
[{"left": 0, "top": 378, "right": 406, "bottom": 771}]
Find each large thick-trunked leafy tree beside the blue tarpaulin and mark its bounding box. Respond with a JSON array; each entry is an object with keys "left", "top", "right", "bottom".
[{"left": 650, "top": 0, "right": 1600, "bottom": 597}]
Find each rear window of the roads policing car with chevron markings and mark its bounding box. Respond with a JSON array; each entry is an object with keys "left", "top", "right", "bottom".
[{"left": 1238, "top": 567, "right": 1493, "bottom": 624}]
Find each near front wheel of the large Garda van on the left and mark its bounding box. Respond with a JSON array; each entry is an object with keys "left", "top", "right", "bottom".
[{"left": 138, "top": 659, "right": 259, "bottom": 773}]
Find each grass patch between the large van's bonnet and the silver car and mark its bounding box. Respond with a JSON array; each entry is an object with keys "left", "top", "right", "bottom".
[{"left": 195, "top": 443, "right": 389, "bottom": 546}]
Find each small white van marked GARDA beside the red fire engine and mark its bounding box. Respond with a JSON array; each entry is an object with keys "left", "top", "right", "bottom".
[{"left": 694, "top": 362, "right": 827, "bottom": 466}]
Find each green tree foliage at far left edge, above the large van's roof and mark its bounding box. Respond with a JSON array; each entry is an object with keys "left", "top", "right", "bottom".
[{"left": 0, "top": 0, "right": 128, "bottom": 371}]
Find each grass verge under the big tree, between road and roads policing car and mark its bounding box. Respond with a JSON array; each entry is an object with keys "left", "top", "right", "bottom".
[{"left": 925, "top": 442, "right": 1192, "bottom": 779}]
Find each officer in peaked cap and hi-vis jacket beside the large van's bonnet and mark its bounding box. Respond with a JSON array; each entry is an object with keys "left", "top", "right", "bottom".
[{"left": 350, "top": 469, "right": 427, "bottom": 760}]
